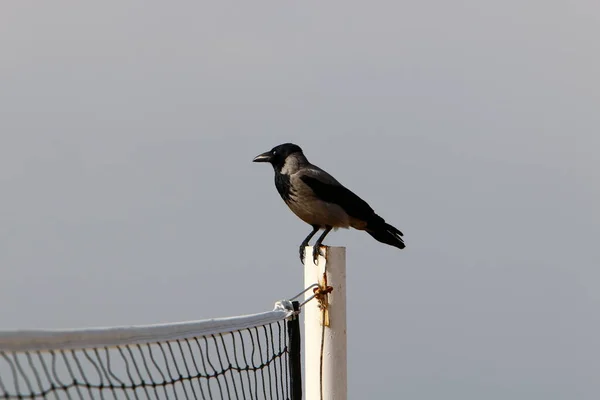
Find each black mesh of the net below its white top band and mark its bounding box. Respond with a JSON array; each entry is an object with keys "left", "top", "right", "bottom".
[{"left": 0, "top": 310, "right": 301, "bottom": 399}]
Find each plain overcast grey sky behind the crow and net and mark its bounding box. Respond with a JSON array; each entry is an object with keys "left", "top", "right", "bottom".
[{"left": 0, "top": 0, "right": 600, "bottom": 400}]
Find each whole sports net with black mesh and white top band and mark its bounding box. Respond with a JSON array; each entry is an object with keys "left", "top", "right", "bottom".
[{"left": 0, "top": 301, "right": 301, "bottom": 400}]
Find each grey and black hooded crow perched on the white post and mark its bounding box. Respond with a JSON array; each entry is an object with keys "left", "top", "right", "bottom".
[{"left": 252, "top": 143, "right": 405, "bottom": 264}]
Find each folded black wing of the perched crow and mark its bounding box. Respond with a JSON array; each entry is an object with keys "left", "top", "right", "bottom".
[{"left": 300, "top": 171, "right": 374, "bottom": 222}]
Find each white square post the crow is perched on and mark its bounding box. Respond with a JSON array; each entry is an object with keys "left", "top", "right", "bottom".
[{"left": 302, "top": 246, "right": 348, "bottom": 400}]
